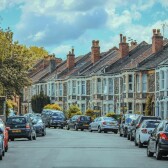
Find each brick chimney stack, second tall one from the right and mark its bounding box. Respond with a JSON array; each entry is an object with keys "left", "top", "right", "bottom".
[{"left": 119, "top": 34, "right": 129, "bottom": 58}]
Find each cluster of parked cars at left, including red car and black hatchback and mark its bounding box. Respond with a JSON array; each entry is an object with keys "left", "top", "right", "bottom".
[{"left": 0, "top": 113, "right": 46, "bottom": 160}]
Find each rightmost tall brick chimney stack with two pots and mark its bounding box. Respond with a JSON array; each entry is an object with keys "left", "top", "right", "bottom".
[{"left": 152, "top": 29, "right": 163, "bottom": 53}]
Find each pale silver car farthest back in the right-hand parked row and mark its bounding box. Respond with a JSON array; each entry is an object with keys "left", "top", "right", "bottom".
[{"left": 119, "top": 114, "right": 139, "bottom": 139}]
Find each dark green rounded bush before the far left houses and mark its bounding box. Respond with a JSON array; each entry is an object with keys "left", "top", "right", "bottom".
[{"left": 31, "top": 92, "right": 50, "bottom": 113}]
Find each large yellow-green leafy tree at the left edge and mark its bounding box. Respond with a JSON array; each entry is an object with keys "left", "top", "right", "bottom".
[{"left": 0, "top": 29, "right": 47, "bottom": 95}]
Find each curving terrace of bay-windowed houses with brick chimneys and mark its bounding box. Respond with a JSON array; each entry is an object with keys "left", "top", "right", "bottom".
[{"left": 22, "top": 29, "right": 168, "bottom": 118}]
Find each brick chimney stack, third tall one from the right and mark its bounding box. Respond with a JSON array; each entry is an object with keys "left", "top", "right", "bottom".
[{"left": 91, "top": 40, "right": 100, "bottom": 64}]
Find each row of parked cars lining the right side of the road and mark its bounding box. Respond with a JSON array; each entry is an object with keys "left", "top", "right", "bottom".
[{"left": 119, "top": 114, "right": 168, "bottom": 160}]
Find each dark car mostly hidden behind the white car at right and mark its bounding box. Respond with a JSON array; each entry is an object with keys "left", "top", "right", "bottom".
[{"left": 130, "top": 115, "right": 161, "bottom": 145}]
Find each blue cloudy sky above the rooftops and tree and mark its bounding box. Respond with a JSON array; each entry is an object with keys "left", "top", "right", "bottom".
[{"left": 0, "top": 0, "right": 168, "bottom": 60}]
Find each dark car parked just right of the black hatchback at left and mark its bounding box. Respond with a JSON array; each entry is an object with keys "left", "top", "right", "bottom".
[{"left": 32, "top": 117, "right": 46, "bottom": 136}]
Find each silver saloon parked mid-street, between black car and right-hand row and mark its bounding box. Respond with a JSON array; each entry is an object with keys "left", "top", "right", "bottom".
[{"left": 89, "top": 117, "right": 119, "bottom": 134}]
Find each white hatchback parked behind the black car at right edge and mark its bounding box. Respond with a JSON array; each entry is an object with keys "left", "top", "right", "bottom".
[{"left": 135, "top": 120, "right": 160, "bottom": 148}]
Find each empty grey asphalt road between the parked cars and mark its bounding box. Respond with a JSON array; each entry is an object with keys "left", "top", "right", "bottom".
[{"left": 0, "top": 128, "right": 168, "bottom": 168}]
